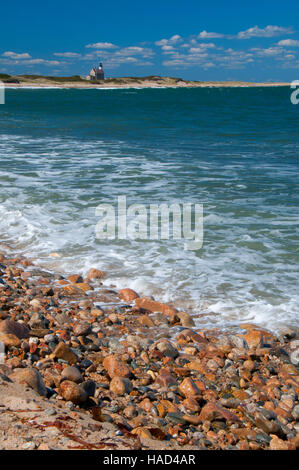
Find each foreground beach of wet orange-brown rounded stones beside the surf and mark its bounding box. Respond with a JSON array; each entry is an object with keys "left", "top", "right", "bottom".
[{"left": 0, "top": 252, "right": 299, "bottom": 450}]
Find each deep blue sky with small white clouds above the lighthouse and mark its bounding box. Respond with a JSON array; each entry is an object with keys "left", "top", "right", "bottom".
[{"left": 0, "top": 0, "right": 299, "bottom": 81}]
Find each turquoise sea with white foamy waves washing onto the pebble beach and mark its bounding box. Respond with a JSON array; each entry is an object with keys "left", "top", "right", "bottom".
[{"left": 0, "top": 87, "right": 299, "bottom": 329}]
